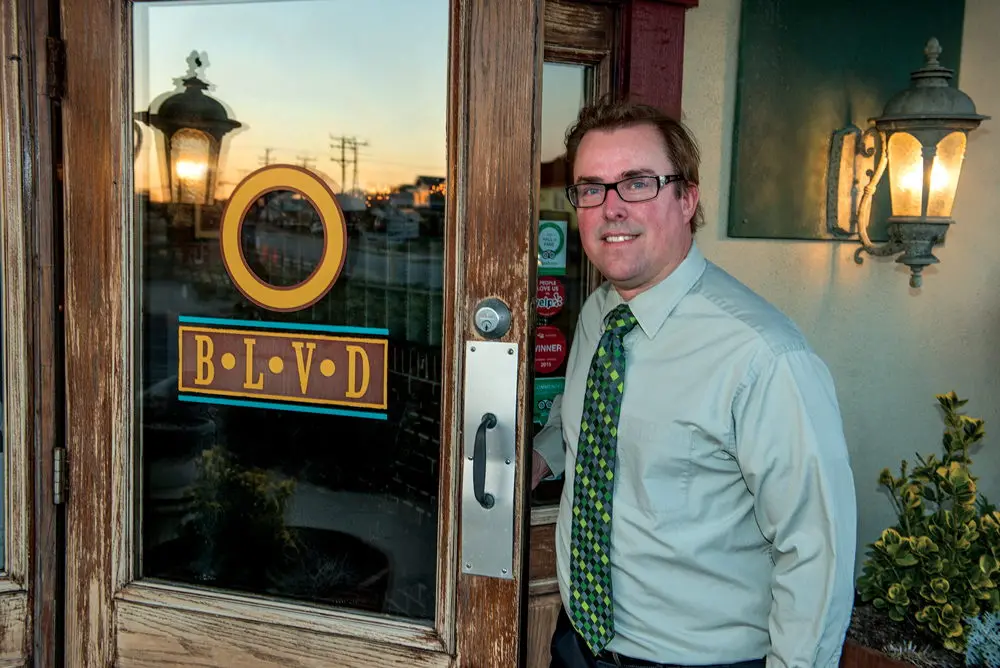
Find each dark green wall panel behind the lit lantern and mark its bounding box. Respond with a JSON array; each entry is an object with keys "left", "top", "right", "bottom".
[{"left": 728, "top": 0, "right": 964, "bottom": 240}]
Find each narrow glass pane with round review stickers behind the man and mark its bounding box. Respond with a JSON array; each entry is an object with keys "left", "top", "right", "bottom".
[{"left": 532, "top": 63, "right": 593, "bottom": 505}]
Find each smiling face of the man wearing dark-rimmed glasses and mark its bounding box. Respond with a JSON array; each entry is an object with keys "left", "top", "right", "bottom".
[{"left": 573, "top": 125, "right": 698, "bottom": 300}]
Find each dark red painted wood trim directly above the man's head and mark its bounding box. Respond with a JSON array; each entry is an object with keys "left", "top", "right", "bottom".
[{"left": 616, "top": 0, "right": 698, "bottom": 119}]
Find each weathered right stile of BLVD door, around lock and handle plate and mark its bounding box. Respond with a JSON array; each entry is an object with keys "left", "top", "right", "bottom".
[{"left": 456, "top": 0, "right": 542, "bottom": 666}]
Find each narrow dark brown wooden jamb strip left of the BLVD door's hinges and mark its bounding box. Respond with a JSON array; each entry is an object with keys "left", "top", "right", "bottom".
[{"left": 14, "top": 0, "right": 64, "bottom": 666}]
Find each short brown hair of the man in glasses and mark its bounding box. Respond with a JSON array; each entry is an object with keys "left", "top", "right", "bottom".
[{"left": 566, "top": 99, "right": 705, "bottom": 234}]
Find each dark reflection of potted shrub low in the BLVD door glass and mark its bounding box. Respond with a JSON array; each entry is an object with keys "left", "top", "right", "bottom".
[{"left": 144, "top": 445, "right": 392, "bottom": 612}]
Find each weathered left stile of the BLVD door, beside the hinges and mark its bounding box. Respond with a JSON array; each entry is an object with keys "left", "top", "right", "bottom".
[{"left": 62, "top": 0, "right": 132, "bottom": 668}]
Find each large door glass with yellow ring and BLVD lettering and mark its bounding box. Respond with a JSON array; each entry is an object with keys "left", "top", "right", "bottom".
[{"left": 134, "top": 0, "right": 449, "bottom": 621}]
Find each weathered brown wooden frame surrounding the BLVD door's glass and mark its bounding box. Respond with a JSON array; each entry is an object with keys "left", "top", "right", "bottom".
[{"left": 62, "top": 0, "right": 542, "bottom": 667}]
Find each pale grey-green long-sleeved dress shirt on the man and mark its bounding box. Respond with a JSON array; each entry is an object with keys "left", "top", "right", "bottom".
[{"left": 534, "top": 245, "right": 856, "bottom": 668}]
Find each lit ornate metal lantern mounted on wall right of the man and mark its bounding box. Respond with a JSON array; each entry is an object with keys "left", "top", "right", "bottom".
[{"left": 828, "top": 38, "right": 989, "bottom": 288}]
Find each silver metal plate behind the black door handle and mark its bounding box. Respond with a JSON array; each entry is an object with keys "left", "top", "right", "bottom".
[{"left": 461, "top": 341, "right": 518, "bottom": 579}]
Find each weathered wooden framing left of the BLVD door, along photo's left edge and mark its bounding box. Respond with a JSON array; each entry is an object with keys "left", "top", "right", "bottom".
[{"left": 0, "top": 0, "right": 62, "bottom": 665}]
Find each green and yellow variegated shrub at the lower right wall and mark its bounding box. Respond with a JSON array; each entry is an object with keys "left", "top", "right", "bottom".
[{"left": 841, "top": 392, "right": 1000, "bottom": 668}]
